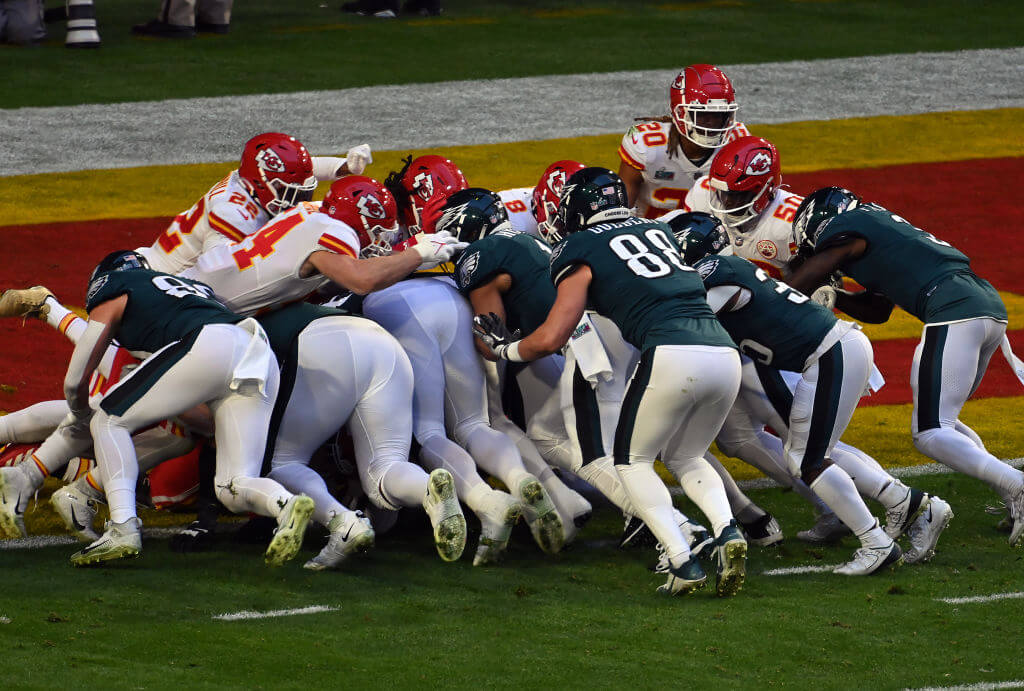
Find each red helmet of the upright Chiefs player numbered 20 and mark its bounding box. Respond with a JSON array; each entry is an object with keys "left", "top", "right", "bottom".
[{"left": 669, "top": 64, "right": 739, "bottom": 148}]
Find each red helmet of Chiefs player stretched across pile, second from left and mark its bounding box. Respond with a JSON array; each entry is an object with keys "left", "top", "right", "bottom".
[{"left": 321, "top": 175, "right": 401, "bottom": 257}]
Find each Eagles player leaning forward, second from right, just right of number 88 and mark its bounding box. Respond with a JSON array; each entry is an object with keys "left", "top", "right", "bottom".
[{"left": 673, "top": 214, "right": 952, "bottom": 575}]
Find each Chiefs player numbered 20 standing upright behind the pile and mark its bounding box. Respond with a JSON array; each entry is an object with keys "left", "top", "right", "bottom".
[{"left": 618, "top": 64, "right": 750, "bottom": 218}]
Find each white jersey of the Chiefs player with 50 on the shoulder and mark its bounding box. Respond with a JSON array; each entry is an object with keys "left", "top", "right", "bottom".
[{"left": 685, "top": 176, "right": 804, "bottom": 278}]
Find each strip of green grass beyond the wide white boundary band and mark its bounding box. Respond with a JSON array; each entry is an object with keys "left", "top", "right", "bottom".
[{"left": 6, "top": 0, "right": 1024, "bottom": 109}]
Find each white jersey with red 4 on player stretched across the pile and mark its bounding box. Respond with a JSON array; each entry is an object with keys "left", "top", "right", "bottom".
[{"left": 181, "top": 202, "right": 359, "bottom": 316}]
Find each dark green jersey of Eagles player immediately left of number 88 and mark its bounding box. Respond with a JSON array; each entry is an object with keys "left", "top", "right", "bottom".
[{"left": 455, "top": 230, "right": 555, "bottom": 335}]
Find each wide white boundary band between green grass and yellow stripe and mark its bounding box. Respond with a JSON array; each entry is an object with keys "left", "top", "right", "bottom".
[{"left": 0, "top": 48, "right": 1024, "bottom": 176}]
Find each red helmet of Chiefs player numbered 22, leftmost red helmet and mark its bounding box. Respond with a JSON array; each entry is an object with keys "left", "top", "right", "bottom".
[{"left": 239, "top": 132, "right": 316, "bottom": 216}]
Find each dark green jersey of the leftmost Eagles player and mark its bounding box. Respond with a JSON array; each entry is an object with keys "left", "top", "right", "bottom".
[{"left": 85, "top": 269, "right": 244, "bottom": 353}]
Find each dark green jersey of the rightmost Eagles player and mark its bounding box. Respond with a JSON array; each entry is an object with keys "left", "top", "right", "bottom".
[{"left": 815, "top": 204, "right": 1007, "bottom": 323}]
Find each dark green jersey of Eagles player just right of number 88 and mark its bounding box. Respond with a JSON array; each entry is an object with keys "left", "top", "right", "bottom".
[{"left": 693, "top": 255, "right": 838, "bottom": 372}]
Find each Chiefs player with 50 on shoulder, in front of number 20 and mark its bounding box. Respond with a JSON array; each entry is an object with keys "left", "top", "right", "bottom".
[{"left": 684, "top": 136, "right": 804, "bottom": 278}]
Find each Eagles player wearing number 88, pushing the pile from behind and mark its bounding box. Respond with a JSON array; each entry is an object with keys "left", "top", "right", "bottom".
[{"left": 477, "top": 168, "right": 746, "bottom": 595}]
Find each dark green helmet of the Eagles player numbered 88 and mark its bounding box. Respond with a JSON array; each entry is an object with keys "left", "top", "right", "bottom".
[{"left": 547, "top": 168, "right": 630, "bottom": 244}]
